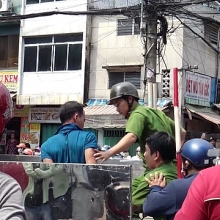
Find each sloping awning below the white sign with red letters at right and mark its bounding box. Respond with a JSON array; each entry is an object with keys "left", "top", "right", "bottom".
[{"left": 185, "top": 105, "right": 220, "bottom": 125}]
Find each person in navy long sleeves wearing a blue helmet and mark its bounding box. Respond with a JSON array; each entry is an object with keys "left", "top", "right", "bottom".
[{"left": 143, "top": 138, "right": 214, "bottom": 220}]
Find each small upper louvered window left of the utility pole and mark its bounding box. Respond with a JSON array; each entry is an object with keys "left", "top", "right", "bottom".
[{"left": 117, "top": 18, "right": 140, "bottom": 36}]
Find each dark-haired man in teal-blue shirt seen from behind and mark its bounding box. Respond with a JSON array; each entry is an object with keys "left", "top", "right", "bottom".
[{"left": 41, "top": 101, "right": 97, "bottom": 164}]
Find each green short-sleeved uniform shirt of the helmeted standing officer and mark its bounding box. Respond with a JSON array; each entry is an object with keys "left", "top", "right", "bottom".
[{"left": 125, "top": 104, "right": 175, "bottom": 153}]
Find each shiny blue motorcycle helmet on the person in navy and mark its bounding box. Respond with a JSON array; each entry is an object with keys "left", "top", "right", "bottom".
[{"left": 179, "top": 138, "right": 214, "bottom": 168}]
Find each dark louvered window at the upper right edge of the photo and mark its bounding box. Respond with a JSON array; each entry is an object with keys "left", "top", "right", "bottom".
[{"left": 204, "top": 24, "right": 219, "bottom": 45}]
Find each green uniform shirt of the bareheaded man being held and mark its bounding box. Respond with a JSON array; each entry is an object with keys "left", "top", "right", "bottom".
[{"left": 132, "top": 162, "right": 177, "bottom": 219}]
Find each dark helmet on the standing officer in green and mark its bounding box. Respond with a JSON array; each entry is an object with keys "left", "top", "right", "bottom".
[{"left": 108, "top": 82, "right": 139, "bottom": 105}]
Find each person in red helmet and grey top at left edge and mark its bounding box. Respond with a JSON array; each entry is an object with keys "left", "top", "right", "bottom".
[{"left": 0, "top": 82, "right": 27, "bottom": 220}]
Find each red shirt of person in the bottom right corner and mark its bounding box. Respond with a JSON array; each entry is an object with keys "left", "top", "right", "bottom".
[{"left": 175, "top": 166, "right": 220, "bottom": 220}]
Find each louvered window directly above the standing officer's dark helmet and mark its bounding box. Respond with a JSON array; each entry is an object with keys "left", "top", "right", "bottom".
[{"left": 108, "top": 72, "right": 141, "bottom": 89}]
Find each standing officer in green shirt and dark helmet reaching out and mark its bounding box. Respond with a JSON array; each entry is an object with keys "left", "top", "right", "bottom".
[{"left": 95, "top": 82, "right": 186, "bottom": 162}]
